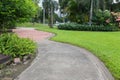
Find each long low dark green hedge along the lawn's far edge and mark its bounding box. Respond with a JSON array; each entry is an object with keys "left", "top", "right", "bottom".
[{"left": 58, "top": 23, "right": 119, "bottom": 31}]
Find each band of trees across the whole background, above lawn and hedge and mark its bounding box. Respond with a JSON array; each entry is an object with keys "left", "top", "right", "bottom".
[{"left": 0, "top": 0, "right": 120, "bottom": 29}]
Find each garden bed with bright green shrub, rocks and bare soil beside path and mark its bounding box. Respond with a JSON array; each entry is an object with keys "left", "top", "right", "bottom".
[{"left": 0, "top": 33, "right": 37, "bottom": 80}]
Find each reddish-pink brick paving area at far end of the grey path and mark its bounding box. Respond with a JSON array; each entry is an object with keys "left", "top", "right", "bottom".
[{"left": 13, "top": 28, "right": 52, "bottom": 42}]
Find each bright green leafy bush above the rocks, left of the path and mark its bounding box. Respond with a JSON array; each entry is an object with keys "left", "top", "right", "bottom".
[{"left": 0, "top": 33, "right": 36, "bottom": 58}]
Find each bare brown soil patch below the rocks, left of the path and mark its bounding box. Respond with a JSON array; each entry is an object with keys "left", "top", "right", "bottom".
[{"left": 0, "top": 52, "right": 35, "bottom": 80}]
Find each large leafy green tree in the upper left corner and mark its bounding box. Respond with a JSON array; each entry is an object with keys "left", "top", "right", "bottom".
[{"left": 0, "top": 0, "right": 38, "bottom": 29}]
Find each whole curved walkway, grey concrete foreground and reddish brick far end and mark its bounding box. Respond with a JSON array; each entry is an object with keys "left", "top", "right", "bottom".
[{"left": 14, "top": 29, "right": 114, "bottom": 80}]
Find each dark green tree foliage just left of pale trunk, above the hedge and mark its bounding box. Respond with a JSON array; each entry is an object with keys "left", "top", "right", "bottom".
[{"left": 66, "top": 0, "right": 90, "bottom": 23}]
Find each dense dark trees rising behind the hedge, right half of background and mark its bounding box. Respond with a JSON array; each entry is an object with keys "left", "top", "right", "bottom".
[{"left": 59, "top": 0, "right": 120, "bottom": 23}]
